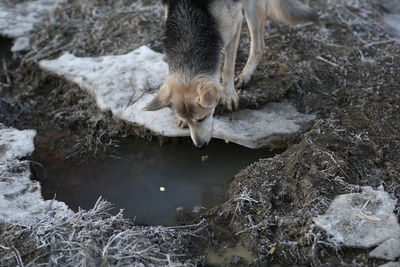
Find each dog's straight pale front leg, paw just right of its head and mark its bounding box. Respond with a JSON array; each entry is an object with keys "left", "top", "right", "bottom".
[{"left": 220, "top": 19, "right": 242, "bottom": 111}]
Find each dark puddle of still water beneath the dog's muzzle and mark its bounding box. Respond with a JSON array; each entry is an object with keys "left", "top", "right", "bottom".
[{"left": 32, "top": 132, "right": 272, "bottom": 225}]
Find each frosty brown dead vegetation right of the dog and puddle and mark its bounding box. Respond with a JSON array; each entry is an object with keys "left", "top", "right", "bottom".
[{"left": 210, "top": 1, "right": 400, "bottom": 266}]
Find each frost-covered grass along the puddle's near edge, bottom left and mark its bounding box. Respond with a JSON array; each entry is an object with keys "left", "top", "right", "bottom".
[{"left": 0, "top": 199, "right": 208, "bottom": 267}]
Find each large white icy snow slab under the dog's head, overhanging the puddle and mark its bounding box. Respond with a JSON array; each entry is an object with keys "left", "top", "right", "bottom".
[{"left": 39, "top": 46, "right": 315, "bottom": 148}]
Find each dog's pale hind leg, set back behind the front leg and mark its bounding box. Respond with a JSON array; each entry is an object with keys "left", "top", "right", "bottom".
[{"left": 236, "top": 0, "right": 267, "bottom": 88}]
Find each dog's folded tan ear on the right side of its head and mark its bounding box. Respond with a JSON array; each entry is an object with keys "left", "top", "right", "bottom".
[{"left": 197, "top": 82, "right": 222, "bottom": 108}]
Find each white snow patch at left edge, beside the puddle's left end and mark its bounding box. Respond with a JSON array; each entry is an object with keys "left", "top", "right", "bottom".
[{"left": 0, "top": 125, "right": 72, "bottom": 225}]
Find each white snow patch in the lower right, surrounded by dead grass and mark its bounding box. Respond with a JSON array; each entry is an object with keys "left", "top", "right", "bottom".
[{"left": 314, "top": 186, "right": 400, "bottom": 259}]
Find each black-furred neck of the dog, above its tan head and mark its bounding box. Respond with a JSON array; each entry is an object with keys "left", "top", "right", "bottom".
[{"left": 165, "top": 0, "right": 223, "bottom": 83}]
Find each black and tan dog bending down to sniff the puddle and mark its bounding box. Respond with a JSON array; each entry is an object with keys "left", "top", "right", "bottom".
[{"left": 145, "top": 0, "right": 316, "bottom": 147}]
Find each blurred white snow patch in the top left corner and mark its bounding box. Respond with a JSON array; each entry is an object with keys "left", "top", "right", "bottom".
[{"left": 0, "top": 0, "right": 65, "bottom": 38}]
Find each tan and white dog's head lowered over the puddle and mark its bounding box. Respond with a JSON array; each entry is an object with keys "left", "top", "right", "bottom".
[{"left": 145, "top": 76, "right": 222, "bottom": 147}]
